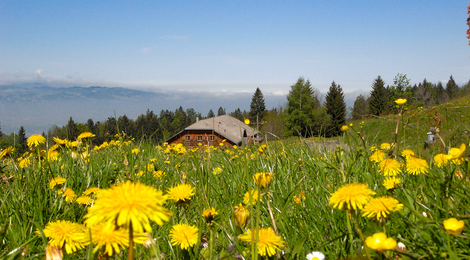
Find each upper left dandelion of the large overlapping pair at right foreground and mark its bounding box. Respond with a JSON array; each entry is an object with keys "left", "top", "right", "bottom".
[{"left": 328, "top": 183, "right": 375, "bottom": 210}]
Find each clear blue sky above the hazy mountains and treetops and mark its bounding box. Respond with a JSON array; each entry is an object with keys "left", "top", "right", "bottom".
[{"left": 0, "top": 0, "right": 470, "bottom": 95}]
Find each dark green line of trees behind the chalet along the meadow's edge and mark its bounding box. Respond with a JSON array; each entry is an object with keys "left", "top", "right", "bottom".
[{"left": 0, "top": 74, "right": 470, "bottom": 154}]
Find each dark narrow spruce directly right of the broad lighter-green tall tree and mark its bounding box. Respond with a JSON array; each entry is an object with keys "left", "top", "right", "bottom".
[{"left": 325, "top": 81, "right": 346, "bottom": 136}]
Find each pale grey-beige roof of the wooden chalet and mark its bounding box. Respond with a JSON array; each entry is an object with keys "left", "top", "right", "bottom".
[{"left": 163, "top": 115, "right": 257, "bottom": 144}]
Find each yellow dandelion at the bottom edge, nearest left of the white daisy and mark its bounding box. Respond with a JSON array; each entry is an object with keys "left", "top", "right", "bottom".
[{"left": 238, "top": 227, "right": 284, "bottom": 256}]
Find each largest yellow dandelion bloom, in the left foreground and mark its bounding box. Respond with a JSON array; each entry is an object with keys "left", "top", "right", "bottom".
[{"left": 84, "top": 181, "right": 172, "bottom": 233}]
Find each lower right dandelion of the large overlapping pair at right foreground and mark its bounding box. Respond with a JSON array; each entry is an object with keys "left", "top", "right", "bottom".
[{"left": 362, "top": 196, "right": 403, "bottom": 220}]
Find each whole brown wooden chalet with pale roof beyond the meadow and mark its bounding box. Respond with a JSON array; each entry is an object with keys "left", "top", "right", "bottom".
[{"left": 165, "top": 115, "right": 258, "bottom": 147}]
